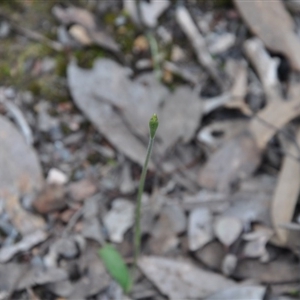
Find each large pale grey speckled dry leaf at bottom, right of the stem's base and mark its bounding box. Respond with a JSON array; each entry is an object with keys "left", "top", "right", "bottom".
[{"left": 138, "top": 256, "right": 235, "bottom": 300}]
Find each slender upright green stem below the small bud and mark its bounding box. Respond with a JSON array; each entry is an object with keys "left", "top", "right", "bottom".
[{"left": 134, "top": 137, "right": 154, "bottom": 270}]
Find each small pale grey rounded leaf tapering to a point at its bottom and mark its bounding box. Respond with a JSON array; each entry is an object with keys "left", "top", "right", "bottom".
[{"left": 214, "top": 216, "right": 243, "bottom": 247}]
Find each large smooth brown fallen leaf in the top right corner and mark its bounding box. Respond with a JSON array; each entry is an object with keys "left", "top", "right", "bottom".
[{"left": 234, "top": 0, "right": 300, "bottom": 71}]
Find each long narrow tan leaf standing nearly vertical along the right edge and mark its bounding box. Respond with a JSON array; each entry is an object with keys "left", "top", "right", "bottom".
[{"left": 271, "top": 128, "right": 300, "bottom": 246}]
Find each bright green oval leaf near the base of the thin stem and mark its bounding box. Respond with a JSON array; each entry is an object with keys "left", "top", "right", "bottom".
[{"left": 99, "top": 244, "right": 132, "bottom": 293}]
